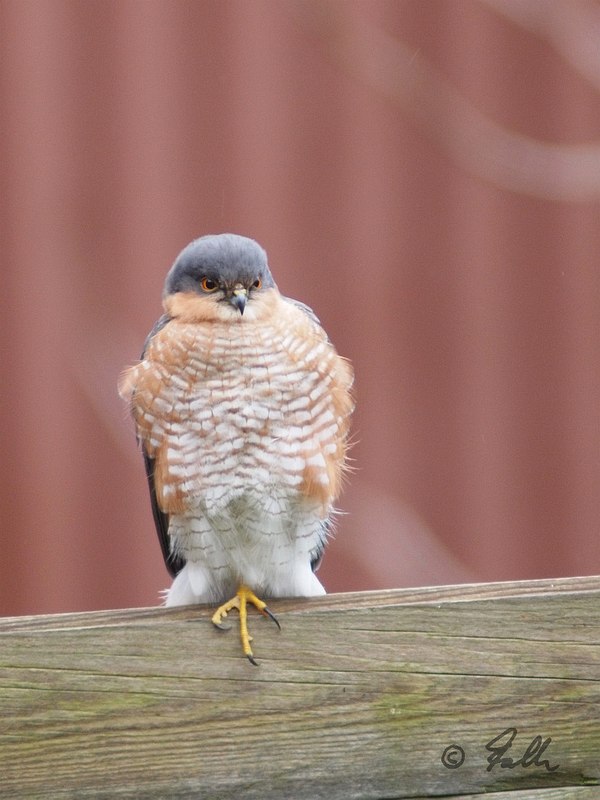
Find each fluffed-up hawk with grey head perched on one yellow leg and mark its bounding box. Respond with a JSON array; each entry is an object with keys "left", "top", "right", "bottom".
[{"left": 119, "top": 233, "right": 354, "bottom": 664}]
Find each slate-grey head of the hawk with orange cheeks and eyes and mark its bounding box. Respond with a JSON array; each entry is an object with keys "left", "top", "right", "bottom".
[{"left": 163, "top": 233, "right": 276, "bottom": 321}]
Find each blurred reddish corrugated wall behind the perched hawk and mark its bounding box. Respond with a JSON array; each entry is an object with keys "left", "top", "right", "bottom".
[{"left": 0, "top": 0, "right": 600, "bottom": 614}]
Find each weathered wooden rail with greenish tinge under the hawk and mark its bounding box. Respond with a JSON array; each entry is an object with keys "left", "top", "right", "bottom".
[{"left": 0, "top": 578, "right": 600, "bottom": 800}]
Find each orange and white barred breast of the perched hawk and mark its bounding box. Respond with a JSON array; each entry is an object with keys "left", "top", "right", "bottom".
[{"left": 135, "top": 309, "right": 352, "bottom": 511}]
